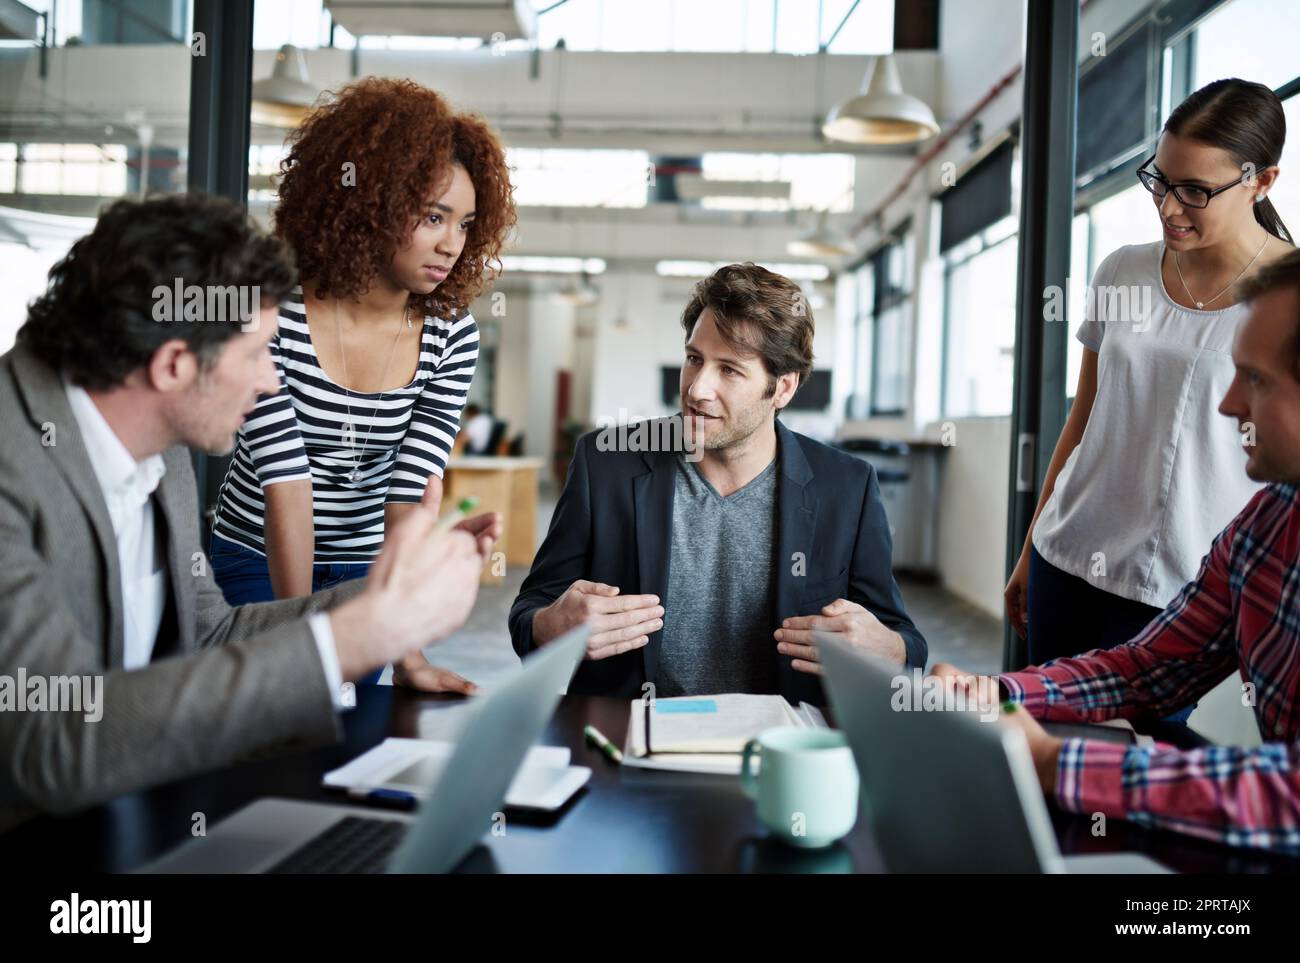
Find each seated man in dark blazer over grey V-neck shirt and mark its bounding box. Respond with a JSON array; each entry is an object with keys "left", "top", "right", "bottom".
[{"left": 510, "top": 264, "right": 926, "bottom": 704}]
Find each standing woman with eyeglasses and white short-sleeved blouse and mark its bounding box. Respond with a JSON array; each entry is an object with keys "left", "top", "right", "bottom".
[{"left": 1005, "top": 79, "right": 1291, "bottom": 686}]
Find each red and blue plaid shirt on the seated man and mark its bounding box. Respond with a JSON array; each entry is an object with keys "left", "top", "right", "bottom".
[{"left": 998, "top": 485, "right": 1300, "bottom": 854}]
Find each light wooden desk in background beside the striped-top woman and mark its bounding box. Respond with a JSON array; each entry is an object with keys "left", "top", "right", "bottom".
[{"left": 442, "top": 455, "right": 546, "bottom": 585}]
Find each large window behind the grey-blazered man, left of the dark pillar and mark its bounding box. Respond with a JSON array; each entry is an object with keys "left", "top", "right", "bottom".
[{"left": 0, "top": 0, "right": 192, "bottom": 353}]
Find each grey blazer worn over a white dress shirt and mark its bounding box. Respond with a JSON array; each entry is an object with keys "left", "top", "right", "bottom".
[{"left": 0, "top": 347, "right": 361, "bottom": 828}]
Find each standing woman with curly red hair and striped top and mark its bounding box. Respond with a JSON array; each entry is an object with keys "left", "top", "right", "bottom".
[{"left": 212, "top": 78, "right": 515, "bottom": 691}]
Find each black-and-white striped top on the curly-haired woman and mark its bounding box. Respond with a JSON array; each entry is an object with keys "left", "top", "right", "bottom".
[{"left": 213, "top": 289, "right": 478, "bottom": 563}]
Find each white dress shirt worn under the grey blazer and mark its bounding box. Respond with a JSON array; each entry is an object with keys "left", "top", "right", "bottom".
[{"left": 64, "top": 381, "right": 355, "bottom": 708}]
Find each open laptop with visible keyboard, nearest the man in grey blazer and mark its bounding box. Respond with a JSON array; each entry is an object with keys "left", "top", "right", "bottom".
[{"left": 140, "top": 626, "right": 590, "bottom": 873}]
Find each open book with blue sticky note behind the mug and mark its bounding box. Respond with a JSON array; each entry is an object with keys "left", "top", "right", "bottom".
[{"left": 623, "top": 693, "right": 826, "bottom": 773}]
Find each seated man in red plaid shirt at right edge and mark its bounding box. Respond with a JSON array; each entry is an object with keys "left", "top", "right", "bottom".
[{"left": 933, "top": 252, "right": 1300, "bottom": 854}]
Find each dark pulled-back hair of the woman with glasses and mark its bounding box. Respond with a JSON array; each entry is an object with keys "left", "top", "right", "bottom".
[{"left": 1165, "top": 77, "right": 1295, "bottom": 243}]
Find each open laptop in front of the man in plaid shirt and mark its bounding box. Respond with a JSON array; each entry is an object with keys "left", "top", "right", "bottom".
[{"left": 815, "top": 633, "right": 1169, "bottom": 873}]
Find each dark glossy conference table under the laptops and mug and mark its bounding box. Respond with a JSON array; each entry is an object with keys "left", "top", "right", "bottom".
[{"left": 0, "top": 685, "right": 1300, "bottom": 873}]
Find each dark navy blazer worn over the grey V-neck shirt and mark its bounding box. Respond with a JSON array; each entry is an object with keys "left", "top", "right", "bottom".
[{"left": 510, "top": 420, "right": 926, "bottom": 706}]
